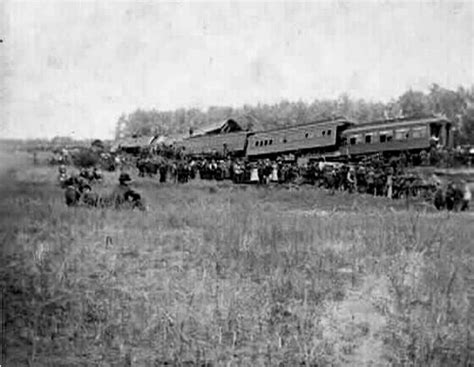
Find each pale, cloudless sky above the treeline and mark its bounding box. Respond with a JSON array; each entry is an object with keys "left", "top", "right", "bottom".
[{"left": 0, "top": 0, "right": 474, "bottom": 139}]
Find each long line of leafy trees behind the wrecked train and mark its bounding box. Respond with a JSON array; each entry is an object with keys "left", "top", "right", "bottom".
[{"left": 116, "top": 84, "right": 474, "bottom": 144}]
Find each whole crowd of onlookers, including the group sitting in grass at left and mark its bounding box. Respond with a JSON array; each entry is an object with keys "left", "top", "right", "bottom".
[{"left": 54, "top": 147, "right": 471, "bottom": 210}]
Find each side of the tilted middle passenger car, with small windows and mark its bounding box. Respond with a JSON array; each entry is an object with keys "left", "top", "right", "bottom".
[{"left": 247, "top": 123, "right": 340, "bottom": 156}]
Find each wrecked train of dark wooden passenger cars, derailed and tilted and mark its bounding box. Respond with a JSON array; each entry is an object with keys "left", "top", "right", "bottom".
[{"left": 175, "top": 115, "right": 453, "bottom": 161}]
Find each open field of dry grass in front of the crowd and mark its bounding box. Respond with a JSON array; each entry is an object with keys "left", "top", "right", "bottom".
[{"left": 0, "top": 151, "right": 474, "bottom": 367}]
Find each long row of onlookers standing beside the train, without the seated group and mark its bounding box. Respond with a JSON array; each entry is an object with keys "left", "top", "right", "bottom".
[{"left": 131, "top": 154, "right": 470, "bottom": 210}]
